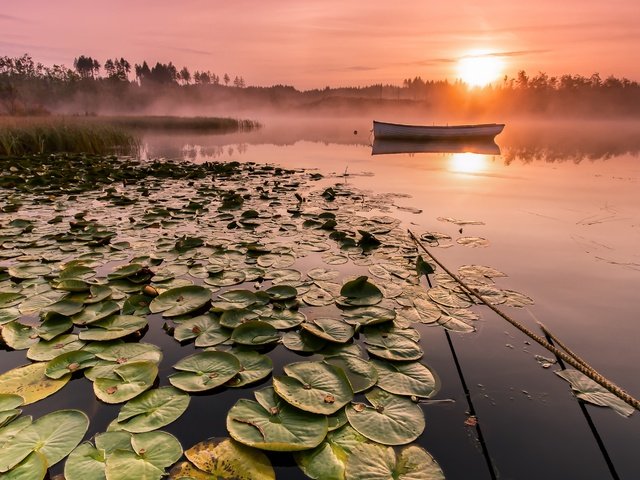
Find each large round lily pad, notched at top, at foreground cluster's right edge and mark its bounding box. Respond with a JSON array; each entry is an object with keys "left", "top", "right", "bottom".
[{"left": 346, "top": 388, "right": 425, "bottom": 445}]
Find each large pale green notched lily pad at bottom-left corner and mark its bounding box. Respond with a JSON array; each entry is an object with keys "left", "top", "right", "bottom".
[{"left": 0, "top": 410, "right": 89, "bottom": 472}]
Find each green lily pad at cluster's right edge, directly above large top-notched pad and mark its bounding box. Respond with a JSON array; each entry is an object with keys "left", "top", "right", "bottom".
[{"left": 371, "top": 359, "right": 439, "bottom": 398}]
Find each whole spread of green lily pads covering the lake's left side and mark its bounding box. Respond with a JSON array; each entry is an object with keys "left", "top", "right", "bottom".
[{"left": 0, "top": 155, "right": 531, "bottom": 480}]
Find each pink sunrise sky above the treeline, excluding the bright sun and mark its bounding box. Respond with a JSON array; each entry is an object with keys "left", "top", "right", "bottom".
[{"left": 0, "top": 0, "right": 640, "bottom": 89}]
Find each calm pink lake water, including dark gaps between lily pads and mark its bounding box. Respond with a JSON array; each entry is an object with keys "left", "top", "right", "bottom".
[{"left": 2, "top": 117, "right": 640, "bottom": 480}]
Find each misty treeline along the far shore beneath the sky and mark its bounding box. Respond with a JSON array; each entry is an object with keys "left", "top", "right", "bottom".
[{"left": 0, "top": 54, "right": 640, "bottom": 118}]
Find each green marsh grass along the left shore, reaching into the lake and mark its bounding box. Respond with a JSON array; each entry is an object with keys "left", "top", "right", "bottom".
[{"left": 0, "top": 116, "right": 260, "bottom": 155}]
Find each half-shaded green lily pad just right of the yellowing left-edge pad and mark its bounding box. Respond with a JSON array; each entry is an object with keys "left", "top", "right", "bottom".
[{"left": 93, "top": 361, "right": 158, "bottom": 403}]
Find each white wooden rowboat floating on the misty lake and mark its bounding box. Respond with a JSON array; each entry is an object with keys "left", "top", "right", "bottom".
[{"left": 373, "top": 120, "right": 504, "bottom": 140}]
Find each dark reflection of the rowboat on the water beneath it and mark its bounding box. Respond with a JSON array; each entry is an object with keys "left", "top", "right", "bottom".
[{"left": 371, "top": 138, "right": 500, "bottom": 155}]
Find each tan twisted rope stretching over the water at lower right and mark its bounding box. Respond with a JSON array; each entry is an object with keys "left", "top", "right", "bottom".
[{"left": 408, "top": 230, "right": 640, "bottom": 410}]
